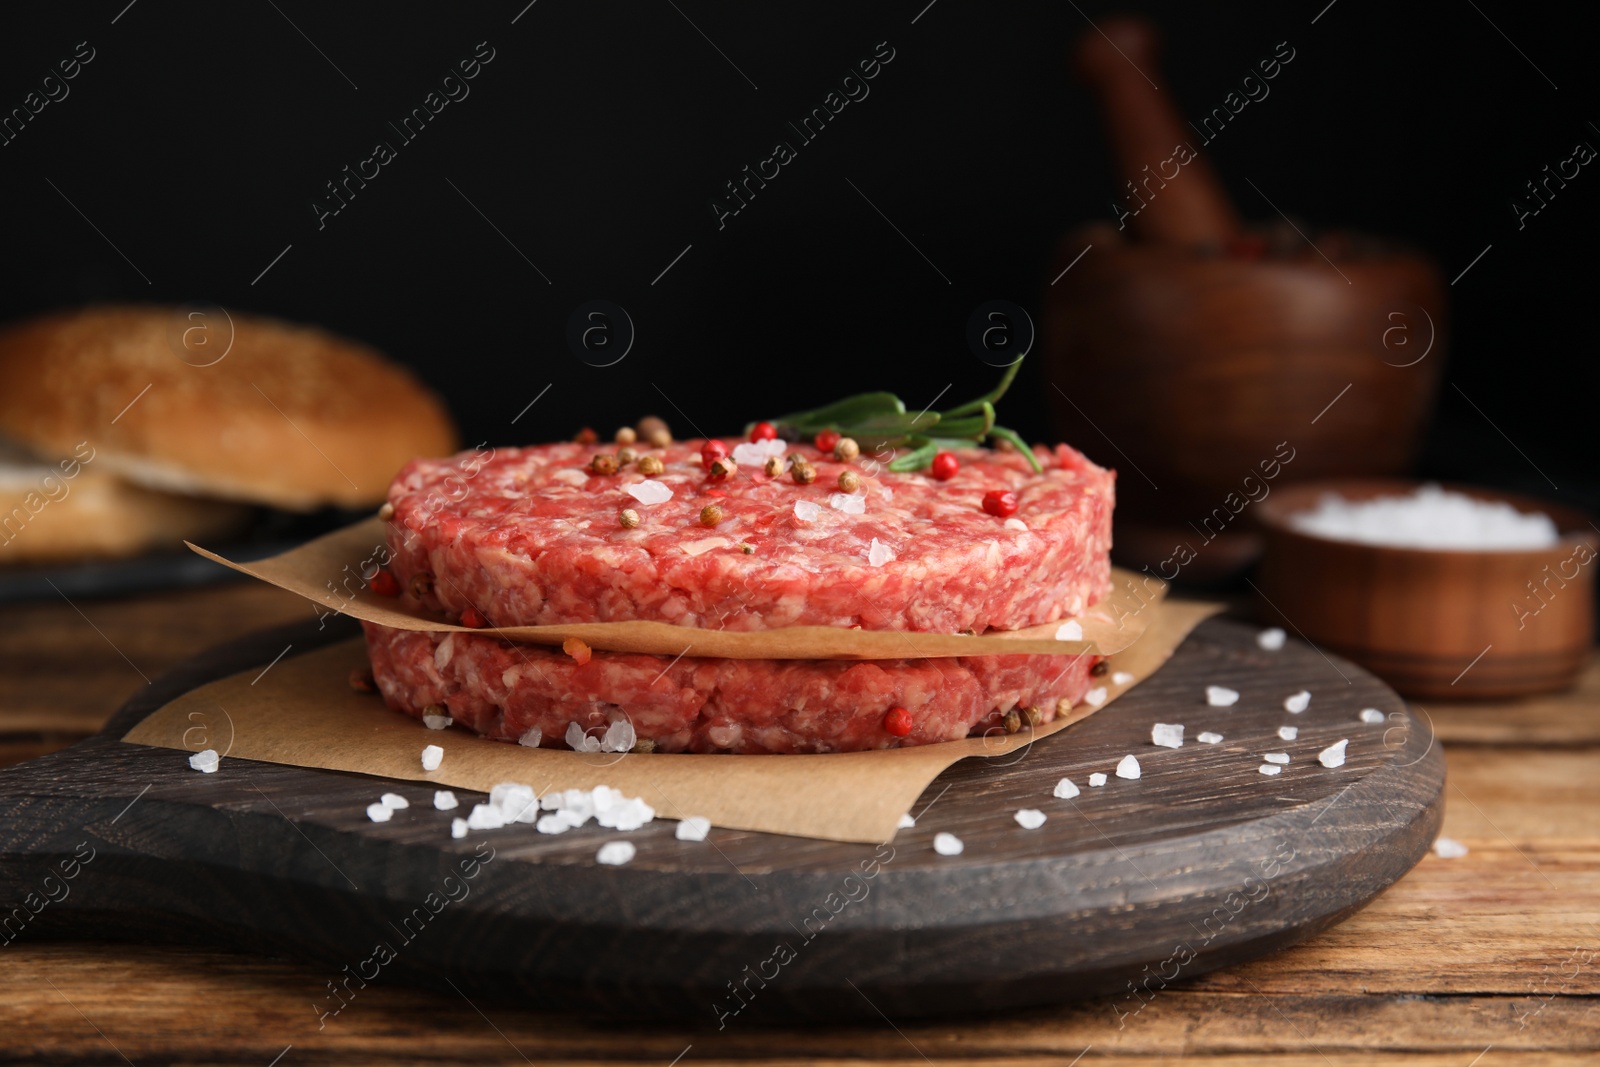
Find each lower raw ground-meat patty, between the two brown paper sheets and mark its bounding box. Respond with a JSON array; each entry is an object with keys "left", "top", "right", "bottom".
[{"left": 363, "top": 622, "right": 1094, "bottom": 753}]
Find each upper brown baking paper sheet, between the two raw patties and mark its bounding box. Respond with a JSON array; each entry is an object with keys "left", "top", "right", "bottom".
[{"left": 184, "top": 517, "right": 1165, "bottom": 659}]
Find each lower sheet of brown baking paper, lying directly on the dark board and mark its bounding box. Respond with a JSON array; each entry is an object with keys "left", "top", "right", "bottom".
[{"left": 123, "top": 600, "right": 1221, "bottom": 843}]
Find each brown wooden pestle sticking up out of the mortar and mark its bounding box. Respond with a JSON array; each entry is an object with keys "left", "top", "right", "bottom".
[{"left": 1074, "top": 16, "right": 1240, "bottom": 246}]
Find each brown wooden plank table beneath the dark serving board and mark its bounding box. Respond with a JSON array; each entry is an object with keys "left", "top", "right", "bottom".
[{"left": 0, "top": 585, "right": 1600, "bottom": 1067}]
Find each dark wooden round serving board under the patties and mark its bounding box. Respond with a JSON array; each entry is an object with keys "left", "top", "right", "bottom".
[{"left": 0, "top": 619, "right": 1445, "bottom": 1027}]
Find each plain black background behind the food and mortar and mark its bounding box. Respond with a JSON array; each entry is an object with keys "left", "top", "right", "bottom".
[{"left": 0, "top": 0, "right": 1600, "bottom": 509}]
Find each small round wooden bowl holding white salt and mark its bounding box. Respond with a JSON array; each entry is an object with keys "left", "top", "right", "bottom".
[{"left": 1254, "top": 478, "right": 1600, "bottom": 699}]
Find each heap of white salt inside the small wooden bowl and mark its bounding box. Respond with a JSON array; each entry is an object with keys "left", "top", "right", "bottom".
[{"left": 1290, "top": 485, "right": 1560, "bottom": 550}]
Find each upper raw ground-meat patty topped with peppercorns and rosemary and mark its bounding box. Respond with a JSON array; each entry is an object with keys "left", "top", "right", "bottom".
[{"left": 389, "top": 440, "right": 1115, "bottom": 632}]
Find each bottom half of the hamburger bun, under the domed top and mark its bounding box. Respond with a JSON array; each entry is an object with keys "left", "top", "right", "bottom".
[{"left": 0, "top": 443, "right": 251, "bottom": 566}]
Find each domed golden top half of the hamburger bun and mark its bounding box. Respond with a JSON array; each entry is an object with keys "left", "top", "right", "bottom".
[{"left": 0, "top": 306, "right": 458, "bottom": 510}]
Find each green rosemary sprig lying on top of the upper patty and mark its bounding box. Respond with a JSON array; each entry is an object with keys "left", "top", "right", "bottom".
[{"left": 771, "top": 360, "right": 1043, "bottom": 472}]
